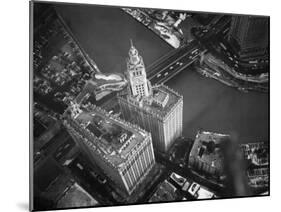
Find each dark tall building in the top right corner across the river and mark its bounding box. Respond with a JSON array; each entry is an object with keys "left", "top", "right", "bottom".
[{"left": 228, "top": 15, "right": 269, "bottom": 60}]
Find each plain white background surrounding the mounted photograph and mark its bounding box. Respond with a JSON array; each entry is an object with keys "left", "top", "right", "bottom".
[{"left": 0, "top": 0, "right": 281, "bottom": 212}]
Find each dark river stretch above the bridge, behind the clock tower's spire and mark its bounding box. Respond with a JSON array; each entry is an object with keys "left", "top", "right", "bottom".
[{"left": 56, "top": 5, "right": 173, "bottom": 73}]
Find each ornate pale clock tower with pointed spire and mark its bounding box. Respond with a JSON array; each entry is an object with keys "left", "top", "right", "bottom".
[{"left": 126, "top": 40, "right": 151, "bottom": 98}]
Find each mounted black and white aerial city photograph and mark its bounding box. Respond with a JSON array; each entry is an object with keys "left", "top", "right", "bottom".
[{"left": 27, "top": 1, "right": 268, "bottom": 211}]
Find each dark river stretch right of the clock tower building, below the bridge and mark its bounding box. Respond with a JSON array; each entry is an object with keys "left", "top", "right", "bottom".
[{"left": 167, "top": 68, "right": 269, "bottom": 143}]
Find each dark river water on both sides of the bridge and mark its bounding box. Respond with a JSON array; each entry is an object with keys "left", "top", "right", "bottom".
[{"left": 56, "top": 5, "right": 269, "bottom": 143}]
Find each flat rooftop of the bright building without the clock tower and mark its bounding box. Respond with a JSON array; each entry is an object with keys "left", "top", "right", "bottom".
[{"left": 69, "top": 105, "right": 149, "bottom": 166}]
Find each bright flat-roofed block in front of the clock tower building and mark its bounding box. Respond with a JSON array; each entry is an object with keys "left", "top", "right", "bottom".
[{"left": 64, "top": 103, "right": 155, "bottom": 194}]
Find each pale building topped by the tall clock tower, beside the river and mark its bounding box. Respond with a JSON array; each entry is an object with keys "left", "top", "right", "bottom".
[{"left": 118, "top": 43, "right": 183, "bottom": 152}]
